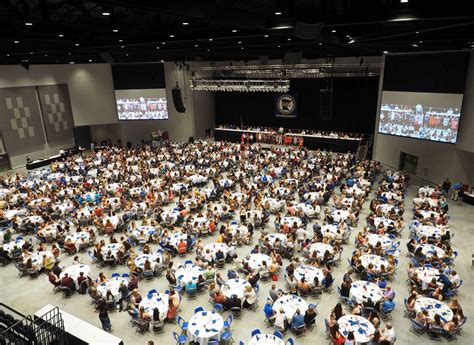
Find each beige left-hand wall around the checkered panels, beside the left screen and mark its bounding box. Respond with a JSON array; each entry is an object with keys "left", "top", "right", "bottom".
[{"left": 0, "top": 64, "right": 117, "bottom": 168}]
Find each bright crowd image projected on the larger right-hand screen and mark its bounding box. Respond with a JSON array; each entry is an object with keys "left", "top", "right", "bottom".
[{"left": 379, "top": 104, "right": 461, "bottom": 143}]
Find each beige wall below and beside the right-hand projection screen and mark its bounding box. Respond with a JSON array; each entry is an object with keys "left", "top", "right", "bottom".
[{"left": 373, "top": 53, "right": 474, "bottom": 186}]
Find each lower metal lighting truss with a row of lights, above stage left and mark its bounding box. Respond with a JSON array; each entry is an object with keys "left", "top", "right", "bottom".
[{"left": 191, "top": 78, "right": 290, "bottom": 92}]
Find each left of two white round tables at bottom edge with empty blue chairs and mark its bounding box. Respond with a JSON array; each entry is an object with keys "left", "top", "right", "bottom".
[{"left": 188, "top": 311, "right": 224, "bottom": 345}]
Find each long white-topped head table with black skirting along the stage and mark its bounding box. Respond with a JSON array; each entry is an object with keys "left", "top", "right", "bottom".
[{"left": 214, "top": 128, "right": 362, "bottom": 152}]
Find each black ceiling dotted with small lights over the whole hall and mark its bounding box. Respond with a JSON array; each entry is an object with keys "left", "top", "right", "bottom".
[{"left": 0, "top": 0, "right": 474, "bottom": 64}]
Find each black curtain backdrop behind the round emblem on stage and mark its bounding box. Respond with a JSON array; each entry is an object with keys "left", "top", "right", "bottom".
[{"left": 215, "top": 77, "right": 379, "bottom": 134}]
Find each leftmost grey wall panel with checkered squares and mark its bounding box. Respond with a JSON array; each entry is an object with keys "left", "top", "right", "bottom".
[{"left": 0, "top": 86, "right": 45, "bottom": 155}]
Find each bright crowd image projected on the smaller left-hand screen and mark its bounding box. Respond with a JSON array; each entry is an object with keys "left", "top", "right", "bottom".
[{"left": 117, "top": 97, "right": 168, "bottom": 120}]
